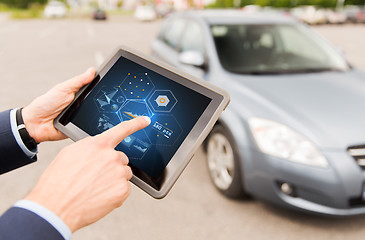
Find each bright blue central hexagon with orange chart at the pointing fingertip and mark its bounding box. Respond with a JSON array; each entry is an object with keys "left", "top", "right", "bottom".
[{"left": 119, "top": 100, "right": 152, "bottom": 120}]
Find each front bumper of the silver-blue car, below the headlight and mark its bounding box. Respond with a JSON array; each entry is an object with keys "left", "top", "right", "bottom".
[{"left": 243, "top": 150, "right": 365, "bottom": 216}]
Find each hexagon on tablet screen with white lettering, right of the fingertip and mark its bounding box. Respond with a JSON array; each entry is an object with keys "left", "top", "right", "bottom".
[{"left": 145, "top": 114, "right": 182, "bottom": 146}]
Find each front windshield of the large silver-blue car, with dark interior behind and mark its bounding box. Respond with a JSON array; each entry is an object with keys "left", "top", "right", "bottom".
[{"left": 211, "top": 24, "right": 349, "bottom": 74}]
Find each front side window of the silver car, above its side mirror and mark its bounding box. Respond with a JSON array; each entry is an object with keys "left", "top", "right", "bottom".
[{"left": 180, "top": 21, "right": 205, "bottom": 54}]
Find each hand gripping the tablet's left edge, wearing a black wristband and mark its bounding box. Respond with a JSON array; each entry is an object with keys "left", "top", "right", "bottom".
[{"left": 22, "top": 68, "right": 95, "bottom": 143}]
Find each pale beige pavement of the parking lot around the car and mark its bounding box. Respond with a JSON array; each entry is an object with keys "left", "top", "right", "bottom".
[{"left": 0, "top": 15, "right": 365, "bottom": 240}]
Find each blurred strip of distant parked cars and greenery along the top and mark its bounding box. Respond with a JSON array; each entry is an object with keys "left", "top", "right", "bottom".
[{"left": 0, "top": 0, "right": 365, "bottom": 24}]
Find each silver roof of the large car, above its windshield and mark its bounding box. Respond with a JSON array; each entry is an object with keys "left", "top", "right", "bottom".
[{"left": 169, "top": 9, "right": 298, "bottom": 25}]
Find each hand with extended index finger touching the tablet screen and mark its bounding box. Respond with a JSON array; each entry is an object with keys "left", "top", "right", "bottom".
[{"left": 25, "top": 117, "right": 151, "bottom": 232}]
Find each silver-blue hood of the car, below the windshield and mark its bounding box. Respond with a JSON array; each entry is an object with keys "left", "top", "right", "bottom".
[{"left": 224, "top": 70, "right": 365, "bottom": 150}]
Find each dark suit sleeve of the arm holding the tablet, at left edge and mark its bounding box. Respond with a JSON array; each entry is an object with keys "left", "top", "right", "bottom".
[{"left": 0, "top": 111, "right": 37, "bottom": 174}]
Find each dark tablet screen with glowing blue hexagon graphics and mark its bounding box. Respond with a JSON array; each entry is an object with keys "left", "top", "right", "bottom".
[{"left": 68, "top": 57, "right": 211, "bottom": 188}]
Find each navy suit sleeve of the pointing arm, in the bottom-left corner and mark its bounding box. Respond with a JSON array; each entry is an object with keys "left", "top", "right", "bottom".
[{"left": 0, "top": 207, "right": 64, "bottom": 240}]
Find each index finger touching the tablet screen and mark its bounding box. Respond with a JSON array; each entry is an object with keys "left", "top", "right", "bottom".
[{"left": 99, "top": 116, "right": 151, "bottom": 147}]
